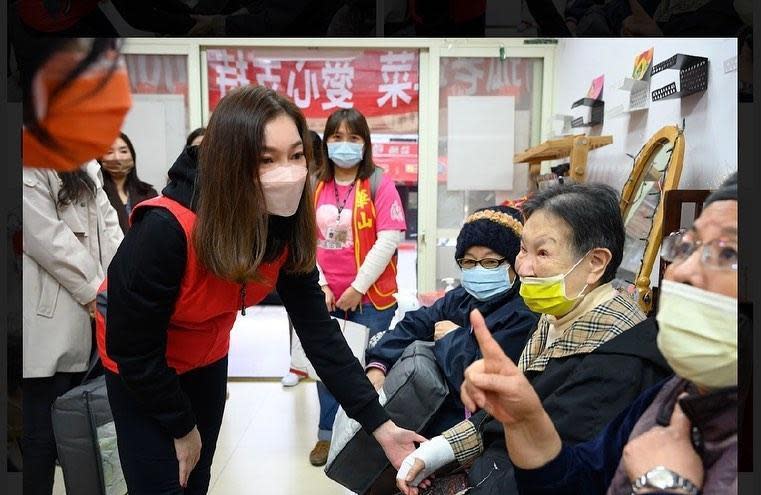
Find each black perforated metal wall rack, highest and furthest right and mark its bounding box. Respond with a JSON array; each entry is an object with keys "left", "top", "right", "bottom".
[{"left": 652, "top": 53, "right": 708, "bottom": 101}]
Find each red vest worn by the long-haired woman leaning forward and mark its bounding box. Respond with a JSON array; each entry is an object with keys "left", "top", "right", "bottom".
[{"left": 96, "top": 196, "right": 287, "bottom": 374}]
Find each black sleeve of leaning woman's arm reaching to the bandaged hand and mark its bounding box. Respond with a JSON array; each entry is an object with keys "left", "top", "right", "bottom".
[{"left": 277, "top": 268, "right": 389, "bottom": 433}]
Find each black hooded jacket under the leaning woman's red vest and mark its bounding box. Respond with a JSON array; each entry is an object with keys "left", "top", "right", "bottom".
[{"left": 106, "top": 147, "right": 388, "bottom": 438}]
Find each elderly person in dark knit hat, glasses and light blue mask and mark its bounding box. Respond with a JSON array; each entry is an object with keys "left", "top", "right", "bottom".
[{"left": 366, "top": 206, "right": 538, "bottom": 435}]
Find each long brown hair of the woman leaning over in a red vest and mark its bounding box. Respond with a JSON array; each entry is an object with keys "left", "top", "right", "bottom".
[{"left": 193, "top": 86, "right": 317, "bottom": 283}]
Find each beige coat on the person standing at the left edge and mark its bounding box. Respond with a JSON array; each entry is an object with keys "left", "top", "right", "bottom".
[{"left": 23, "top": 161, "right": 124, "bottom": 378}]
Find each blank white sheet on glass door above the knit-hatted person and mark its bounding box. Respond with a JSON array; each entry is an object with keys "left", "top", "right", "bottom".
[{"left": 447, "top": 96, "right": 515, "bottom": 191}]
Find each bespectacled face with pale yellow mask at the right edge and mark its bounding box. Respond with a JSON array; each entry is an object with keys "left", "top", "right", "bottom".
[{"left": 657, "top": 201, "right": 737, "bottom": 390}]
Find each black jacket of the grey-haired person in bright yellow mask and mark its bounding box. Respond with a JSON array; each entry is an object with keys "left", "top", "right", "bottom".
[{"left": 469, "top": 318, "right": 673, "bottom": 495}]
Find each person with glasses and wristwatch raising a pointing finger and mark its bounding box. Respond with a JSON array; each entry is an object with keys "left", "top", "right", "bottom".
[{"left": 436, "top": 174, "right": 740, "bottom": 495}]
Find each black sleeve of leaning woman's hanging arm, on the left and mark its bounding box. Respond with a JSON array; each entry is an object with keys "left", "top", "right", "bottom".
[{"left": 106, "top": 208, "right": 196, "bottom": 438}]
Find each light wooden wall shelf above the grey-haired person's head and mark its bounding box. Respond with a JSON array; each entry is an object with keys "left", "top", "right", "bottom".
[{"left": 513, "top": 134, "right": 613, "bottom": 190}]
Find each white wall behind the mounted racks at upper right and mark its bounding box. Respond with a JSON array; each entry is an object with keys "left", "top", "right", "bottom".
[{"left": 553, "top": 38, "right": 737, "bottom": 190}]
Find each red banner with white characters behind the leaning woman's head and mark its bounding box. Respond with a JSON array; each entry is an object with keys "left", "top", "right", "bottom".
[{"left": 206, "top": 48, "right": 419, "bottom": 118}]
